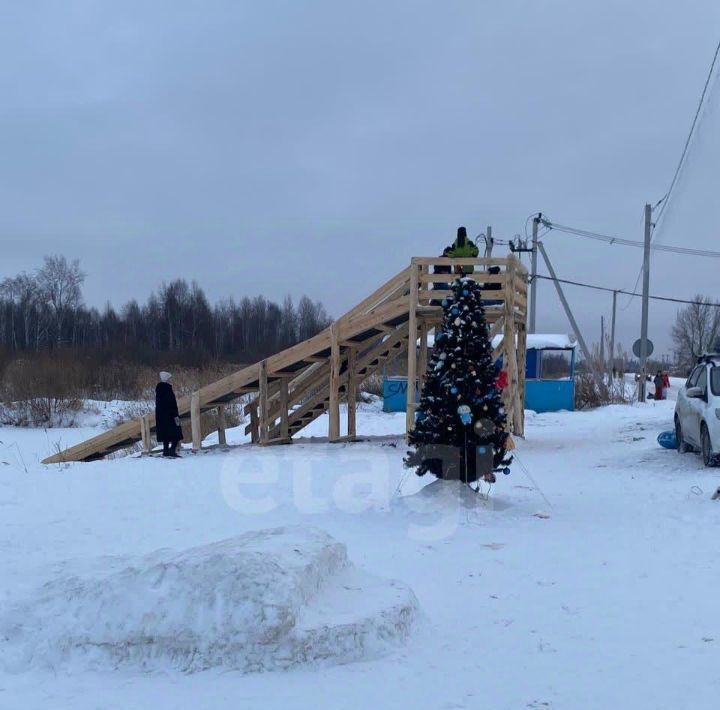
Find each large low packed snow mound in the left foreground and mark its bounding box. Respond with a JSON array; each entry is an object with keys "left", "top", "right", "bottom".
[{"left": 0, "top": 526, "right": 419, "bottom": 672}]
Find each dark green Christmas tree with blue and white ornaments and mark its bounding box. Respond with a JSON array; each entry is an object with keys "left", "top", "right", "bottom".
[{"left": 405, "top": 278, "right": 512, "bottom": 483}]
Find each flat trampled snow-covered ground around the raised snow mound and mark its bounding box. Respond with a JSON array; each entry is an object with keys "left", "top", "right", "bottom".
[{"left": 0, "top": 391, "right": 720, "bottom": 710}]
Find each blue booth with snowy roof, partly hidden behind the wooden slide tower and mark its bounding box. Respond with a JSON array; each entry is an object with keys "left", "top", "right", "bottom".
[{"left": 383, "top": 333, "right": 575, "bottom": 412}]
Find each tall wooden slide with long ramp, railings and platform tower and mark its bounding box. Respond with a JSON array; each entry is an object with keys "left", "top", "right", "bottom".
[{"left": 43, "top": 257, "right": 527, "bottom": 464}]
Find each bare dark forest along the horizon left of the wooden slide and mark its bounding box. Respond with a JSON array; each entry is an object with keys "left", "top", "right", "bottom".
[{"left": 0, "top": 256, "right": 330, "bottom": 364}]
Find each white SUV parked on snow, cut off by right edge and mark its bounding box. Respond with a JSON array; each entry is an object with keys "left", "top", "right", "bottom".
[{"left": 675, "top": 355, "right": 720, "bottom": 466}]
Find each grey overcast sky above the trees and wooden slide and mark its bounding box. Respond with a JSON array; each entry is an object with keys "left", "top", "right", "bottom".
[{"left": 0, "top": 0, "right": 720, "bottom": 352}]
